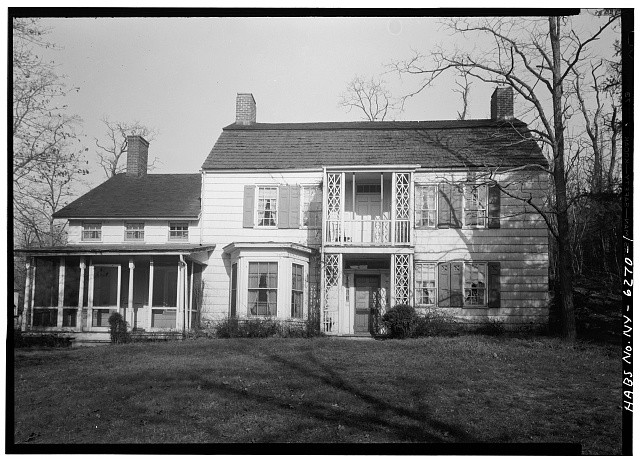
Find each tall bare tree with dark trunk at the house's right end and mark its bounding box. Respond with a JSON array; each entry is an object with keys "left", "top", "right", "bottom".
[{"left": 395, "top": 13, "right": 619, "bottom": 340}]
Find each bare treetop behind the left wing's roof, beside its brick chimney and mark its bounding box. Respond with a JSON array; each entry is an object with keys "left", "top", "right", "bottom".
[{"left": 95, "top": 116, "right": 159, "bottom": 178}]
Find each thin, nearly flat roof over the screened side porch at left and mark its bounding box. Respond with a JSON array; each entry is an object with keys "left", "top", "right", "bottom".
[{"left": 14, "top": 243, "right": 216, "bottom": 256}]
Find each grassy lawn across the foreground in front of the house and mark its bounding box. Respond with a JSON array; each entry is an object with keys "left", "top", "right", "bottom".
[{"left": 14, "top": 335, "right": 622, "bottom": 454}]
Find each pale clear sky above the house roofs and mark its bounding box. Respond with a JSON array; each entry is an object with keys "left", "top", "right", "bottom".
[{"left": 33, "top": 12, "right": 610, "bottom": 191}]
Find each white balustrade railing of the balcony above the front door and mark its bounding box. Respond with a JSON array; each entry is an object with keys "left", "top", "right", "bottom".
[{"left": 325, "top": 218, "right": 411, "bottom": 246}]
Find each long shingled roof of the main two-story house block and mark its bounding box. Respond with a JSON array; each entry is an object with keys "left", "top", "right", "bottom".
[{"left": 202, "top": 119, "right": 547, "bottom": 170}]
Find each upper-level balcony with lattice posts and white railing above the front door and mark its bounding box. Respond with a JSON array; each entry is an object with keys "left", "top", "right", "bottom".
[{"left": 323, "top": 172, "right": 413, "bottom": 246}]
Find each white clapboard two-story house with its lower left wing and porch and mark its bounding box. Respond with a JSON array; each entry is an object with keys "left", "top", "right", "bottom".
[{"left": 20, "top": 88, "right": 548, "bottom": 344}]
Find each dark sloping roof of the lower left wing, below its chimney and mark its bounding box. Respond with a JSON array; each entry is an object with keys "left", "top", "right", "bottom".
[{"left": 53, "top": 174, "right": 202, "bottom": 218}]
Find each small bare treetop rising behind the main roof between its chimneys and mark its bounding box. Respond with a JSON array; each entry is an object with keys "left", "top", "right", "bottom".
[{"left": 338, "top": 75, "right": 393, "bottom": 121}]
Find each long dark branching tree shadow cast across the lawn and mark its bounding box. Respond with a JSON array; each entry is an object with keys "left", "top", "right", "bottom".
[{"left": 182, "top": 352, "right": 477, "bottom": 443}]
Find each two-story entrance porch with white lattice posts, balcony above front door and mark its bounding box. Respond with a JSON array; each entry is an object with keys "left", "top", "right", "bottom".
[{"left": 321, "top": 171, "right": 416, "bottom": 335}]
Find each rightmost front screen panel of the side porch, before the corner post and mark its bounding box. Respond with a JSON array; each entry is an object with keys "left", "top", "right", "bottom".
[{"left": 151, "top": 263, "right": 178, "bottom": 328}]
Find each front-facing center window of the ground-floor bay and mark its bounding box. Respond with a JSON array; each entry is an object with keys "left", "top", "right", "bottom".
[{"left": 248, "top": 262, "right": 278, "bottom": 316}]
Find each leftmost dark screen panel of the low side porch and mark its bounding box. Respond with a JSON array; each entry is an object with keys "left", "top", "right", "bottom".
[{"left": 33, "top": 257, "right": 59, "bottom": 327}]
